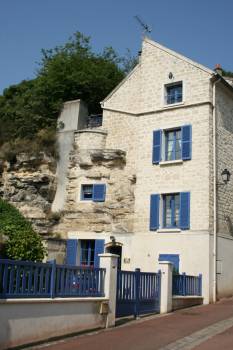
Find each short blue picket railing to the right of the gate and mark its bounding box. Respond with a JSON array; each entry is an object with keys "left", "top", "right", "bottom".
[{"left": 172, "top": 273, "right": 202, "bottom": 296}]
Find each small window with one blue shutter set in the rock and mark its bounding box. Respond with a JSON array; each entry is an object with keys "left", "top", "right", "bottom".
[{"left": 81, "top": 184, "right": 106, "bottom": 202}]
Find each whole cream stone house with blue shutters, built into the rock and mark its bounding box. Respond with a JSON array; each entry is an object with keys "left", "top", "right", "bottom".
[{"left": 53, "top": 38, "right": 233, "bottom": 303}]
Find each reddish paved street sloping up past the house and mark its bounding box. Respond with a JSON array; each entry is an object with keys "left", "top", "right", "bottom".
[{"left": 33, "top": 298, "right": 233, "bottom": 350}]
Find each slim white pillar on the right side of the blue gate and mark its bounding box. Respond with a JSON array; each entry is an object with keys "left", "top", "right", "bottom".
[{"left": 159, "top": 261, "right": 173, "bottom": 314}]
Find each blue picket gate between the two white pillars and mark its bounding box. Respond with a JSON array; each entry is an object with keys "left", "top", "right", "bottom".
[{"left": 116, "top": 269, "right": 161, "bottom": 317}]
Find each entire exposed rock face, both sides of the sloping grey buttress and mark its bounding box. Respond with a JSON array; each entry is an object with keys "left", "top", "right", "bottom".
[{"left": 0, "top": 125, "right": 136, "bottom": 243}]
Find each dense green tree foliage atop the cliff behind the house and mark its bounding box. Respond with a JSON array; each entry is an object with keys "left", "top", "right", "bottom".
[{"left": 0, "top": 32, "right": 135, "bottom": 157}]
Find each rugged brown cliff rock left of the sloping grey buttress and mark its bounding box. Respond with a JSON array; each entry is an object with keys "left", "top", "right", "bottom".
[{"left": 0, "top": 153, "right": 56, "bottom": 234}]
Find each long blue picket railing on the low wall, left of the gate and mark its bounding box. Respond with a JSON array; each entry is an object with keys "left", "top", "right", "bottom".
[{"left": 0, "top": 259, "right": 105, "bottom": 299}]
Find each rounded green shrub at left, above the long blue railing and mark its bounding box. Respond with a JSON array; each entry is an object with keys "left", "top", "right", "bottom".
[{"left": 0, "top": 199, "right": 45, "bottom": 261}]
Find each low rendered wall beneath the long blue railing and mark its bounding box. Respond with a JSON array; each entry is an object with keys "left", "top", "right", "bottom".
[{"left": 0, "top": 298, "right": 106, "bottom": 349}]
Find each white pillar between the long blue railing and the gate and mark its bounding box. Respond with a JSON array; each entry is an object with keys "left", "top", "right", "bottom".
[{"left": 98, "top": 253, "right": 119, "bottom": 328}]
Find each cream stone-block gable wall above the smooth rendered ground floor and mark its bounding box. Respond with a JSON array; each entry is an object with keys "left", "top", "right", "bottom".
[{"left": 103, "top": 38, "right": 212, "bottom": 235}]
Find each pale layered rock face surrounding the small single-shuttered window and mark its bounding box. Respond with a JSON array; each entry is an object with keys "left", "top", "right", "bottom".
[{"left": 53, "top": 134, "right": 136, "bottom": 237}]
